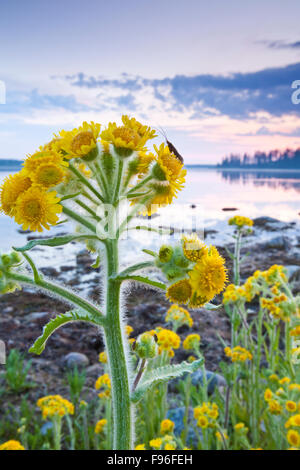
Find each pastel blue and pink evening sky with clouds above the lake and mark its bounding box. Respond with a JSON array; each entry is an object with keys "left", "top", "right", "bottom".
[{"left": 0, "top": 0, "right": 300, "bottom": 164}]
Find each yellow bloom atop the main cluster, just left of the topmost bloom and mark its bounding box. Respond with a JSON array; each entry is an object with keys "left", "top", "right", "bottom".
[{"left": 59, "top": 121, "right": 101, "bottom": 158}]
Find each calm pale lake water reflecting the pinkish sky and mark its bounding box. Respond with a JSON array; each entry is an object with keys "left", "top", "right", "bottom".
[{"left": 0, "top": 168, "right": 300, "bottom": 255}]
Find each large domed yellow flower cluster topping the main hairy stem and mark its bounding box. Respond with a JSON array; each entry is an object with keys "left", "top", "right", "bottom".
[{"left": 0, "top": 115, "right": 186, "bottom": 232}]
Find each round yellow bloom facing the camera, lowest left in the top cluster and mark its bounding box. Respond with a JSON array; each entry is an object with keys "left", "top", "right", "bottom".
[{"left": 15, "top": 186, "right": 63, "bottom": 232}]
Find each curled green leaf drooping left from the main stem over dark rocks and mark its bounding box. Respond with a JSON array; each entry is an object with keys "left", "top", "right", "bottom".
[{"left": 29, "top": 310, "right": 96, "bottom": 354}]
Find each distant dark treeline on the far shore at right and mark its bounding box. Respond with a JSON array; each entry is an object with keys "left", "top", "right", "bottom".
[{"left": 217, "top": 148, "right": 300, "bottom": 170}]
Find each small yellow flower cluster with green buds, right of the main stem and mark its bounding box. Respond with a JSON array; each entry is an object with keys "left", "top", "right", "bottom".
[{"left": 156, "top": 235, "right": 227, "bottom": 308}]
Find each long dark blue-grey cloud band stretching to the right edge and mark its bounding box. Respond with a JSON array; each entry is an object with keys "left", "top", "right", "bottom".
[{"left": 61, "top": 62, "right": 300, "bottom": 119}]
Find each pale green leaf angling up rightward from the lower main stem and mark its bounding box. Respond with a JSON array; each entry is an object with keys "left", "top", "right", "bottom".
[{"left": 131, "top": 359, "right": 203, "bottom": 403}]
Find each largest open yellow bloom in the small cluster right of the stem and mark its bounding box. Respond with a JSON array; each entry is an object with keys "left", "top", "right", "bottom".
[{"left": 189, "top": 247, "right": 227, "bottom": 301}]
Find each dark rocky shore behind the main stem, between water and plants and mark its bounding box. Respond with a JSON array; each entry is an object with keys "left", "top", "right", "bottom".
[{"left": 0, "top": 217, "right": 300, "bottom": 402}]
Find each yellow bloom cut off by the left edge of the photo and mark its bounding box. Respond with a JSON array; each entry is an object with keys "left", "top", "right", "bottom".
[{"left": 0, "top": 170, "right": 32, "bottom": 216}]
